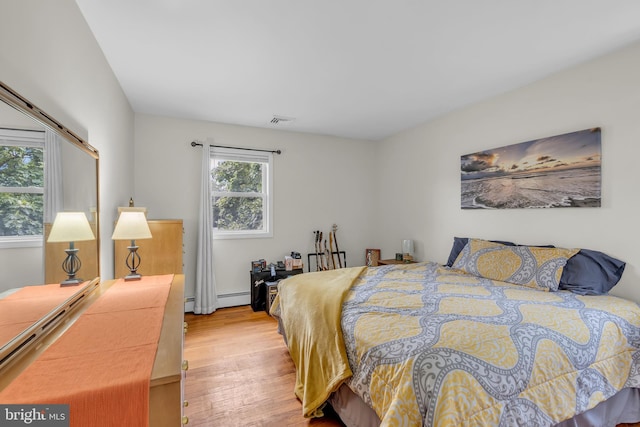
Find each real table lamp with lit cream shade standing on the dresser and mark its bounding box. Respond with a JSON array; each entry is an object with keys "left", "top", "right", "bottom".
[{"left": 111, "top": 210, "right": 152, "bottom": 281}]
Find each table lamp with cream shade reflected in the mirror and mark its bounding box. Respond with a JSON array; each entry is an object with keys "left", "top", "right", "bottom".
[{"left": 47, "top": 212, "right": 96, "bottom": 286}]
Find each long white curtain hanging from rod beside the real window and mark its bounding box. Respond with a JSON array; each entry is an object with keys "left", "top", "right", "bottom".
[{"left": 193, "top": 144, "right": 218, "bottom": 314}]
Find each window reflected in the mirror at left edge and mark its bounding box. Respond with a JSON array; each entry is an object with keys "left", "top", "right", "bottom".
[{"left": 0, "top": 128, "right": 44, "bottom": 247}]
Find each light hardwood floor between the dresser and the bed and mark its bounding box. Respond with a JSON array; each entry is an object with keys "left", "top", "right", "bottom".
[{"left": 184, "top": 306, "right": 640, "bottom": 427}]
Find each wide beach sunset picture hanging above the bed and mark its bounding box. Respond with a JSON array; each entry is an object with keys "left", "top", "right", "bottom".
[{"left": 460, "top": 128, "right": 601, "bottom": 209}]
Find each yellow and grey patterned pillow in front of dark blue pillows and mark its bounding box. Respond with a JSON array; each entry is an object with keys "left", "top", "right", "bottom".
[{"left": 453, "top": 239, "right": 579, "bottom": 291}]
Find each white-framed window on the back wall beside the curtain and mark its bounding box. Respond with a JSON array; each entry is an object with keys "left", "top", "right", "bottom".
[{"left": 211, "top": 147, "right": 273, "bottom": 238}]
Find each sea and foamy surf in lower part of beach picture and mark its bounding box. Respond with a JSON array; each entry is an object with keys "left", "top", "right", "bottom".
[{"left": 461, "top": 165, "right": 600, "bottom": 209}]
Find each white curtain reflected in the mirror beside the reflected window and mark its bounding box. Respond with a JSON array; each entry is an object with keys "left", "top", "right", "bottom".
[{"left": 44, "top": 129, "right": 64, "bottom": 224}]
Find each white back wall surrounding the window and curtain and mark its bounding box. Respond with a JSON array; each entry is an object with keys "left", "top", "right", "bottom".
[{"left": 133, "top": 114, "right": 377, "bottom": 306}]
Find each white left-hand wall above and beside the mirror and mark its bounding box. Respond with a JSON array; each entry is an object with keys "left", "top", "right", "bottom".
[{"left": 0, "top": 0, "right": 133, "bottom": 279}]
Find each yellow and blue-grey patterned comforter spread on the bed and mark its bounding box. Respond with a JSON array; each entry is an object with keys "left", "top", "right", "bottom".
[{"left": 342, "top": 263, "right": 640, "bottom": 426}]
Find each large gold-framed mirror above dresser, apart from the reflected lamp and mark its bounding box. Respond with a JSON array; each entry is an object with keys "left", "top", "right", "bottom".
[{"left": 0, "top": 82, "right": 100, "bottom": 366}]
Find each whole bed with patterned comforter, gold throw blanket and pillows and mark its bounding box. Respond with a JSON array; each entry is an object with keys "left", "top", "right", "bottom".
[{"left": 272, "top": 238, "right": 640, "bottom": 427}]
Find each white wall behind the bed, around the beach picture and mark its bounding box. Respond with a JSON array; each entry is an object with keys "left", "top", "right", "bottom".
[{"left": 378, "top": 39, "right": 640, "bottom": 301}]
